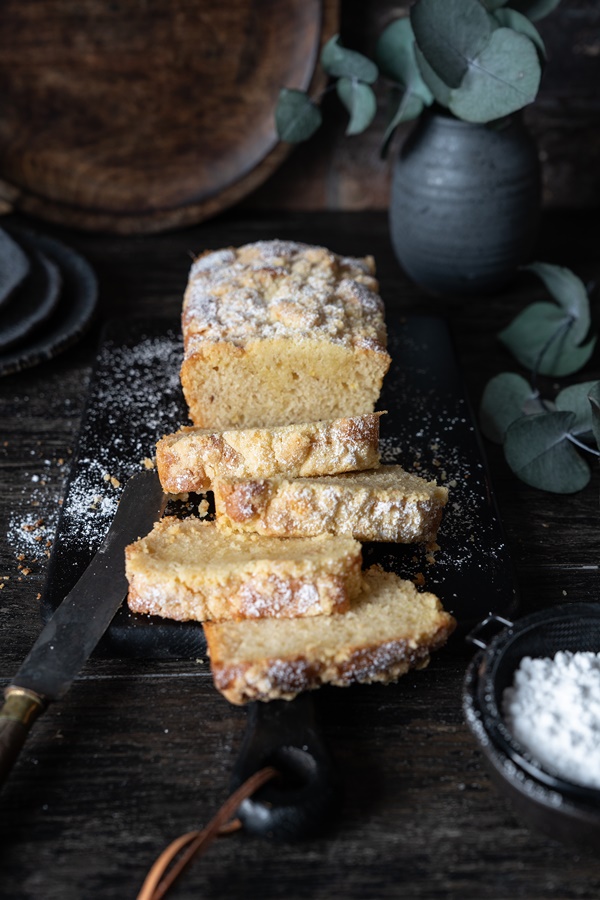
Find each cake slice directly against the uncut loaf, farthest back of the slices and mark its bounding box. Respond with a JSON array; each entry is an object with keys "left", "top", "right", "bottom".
[{"left": 156, "top": 413, "right": 381, "bottom": 494}]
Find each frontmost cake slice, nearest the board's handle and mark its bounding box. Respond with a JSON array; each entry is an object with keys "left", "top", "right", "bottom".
[{"left": 204, "top": 566, "right": 456, "bottom": 704}]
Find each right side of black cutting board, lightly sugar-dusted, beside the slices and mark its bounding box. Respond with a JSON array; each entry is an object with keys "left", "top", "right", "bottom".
[{"left": 366, "top": 317, "right": 516, "bottom": 624}]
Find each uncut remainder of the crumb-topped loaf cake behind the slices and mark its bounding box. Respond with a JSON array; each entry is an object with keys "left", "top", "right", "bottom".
[{"left": 181, "top": 241, "right": 390, "bottom": 429}]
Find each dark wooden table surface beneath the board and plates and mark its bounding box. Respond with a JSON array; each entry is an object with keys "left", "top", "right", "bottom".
[{"left": 0, "top": 212, "right": 600, "bottom": 900}]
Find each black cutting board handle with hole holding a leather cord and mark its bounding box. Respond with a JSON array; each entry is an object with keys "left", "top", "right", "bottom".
[{"left": 231, "top": 694, "right": 342, "bottom": 841}]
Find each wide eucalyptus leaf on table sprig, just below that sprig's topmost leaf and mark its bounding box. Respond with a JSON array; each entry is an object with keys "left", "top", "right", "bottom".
[{"left": 498, "top": 302, "right": 596, "bottom": 376}]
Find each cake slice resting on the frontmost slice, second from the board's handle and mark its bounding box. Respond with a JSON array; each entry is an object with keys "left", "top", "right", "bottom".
[{"left": 125, "top": 517, "right": 362, "bottom": 622}]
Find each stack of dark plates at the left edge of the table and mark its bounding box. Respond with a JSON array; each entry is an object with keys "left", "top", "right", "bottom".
[{"left": 0, "top": 225, "right": 98, "bottom": 375}]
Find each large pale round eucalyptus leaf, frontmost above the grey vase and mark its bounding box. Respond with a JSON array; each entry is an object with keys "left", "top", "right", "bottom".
[{"left": 449, "top": 28, "right": 542, "bottom": 123}]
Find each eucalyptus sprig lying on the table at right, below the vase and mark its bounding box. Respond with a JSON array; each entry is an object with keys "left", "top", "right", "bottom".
[{"left": 480, "top": 263, "right": 600, "bottom": 494}]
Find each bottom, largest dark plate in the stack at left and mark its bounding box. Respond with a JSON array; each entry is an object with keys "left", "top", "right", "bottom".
[{"left": 0, "top": 225, "right": 98, "bottom": 375}]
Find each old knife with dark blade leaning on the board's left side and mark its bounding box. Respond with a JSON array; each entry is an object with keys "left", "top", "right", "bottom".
[{"left": 0, "top": 470, "right": 166, "bottom": 784}]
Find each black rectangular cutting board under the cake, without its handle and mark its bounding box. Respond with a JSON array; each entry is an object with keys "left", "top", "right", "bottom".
[{"left": 42, "top": 316, "right": 516, "bottom": 658}]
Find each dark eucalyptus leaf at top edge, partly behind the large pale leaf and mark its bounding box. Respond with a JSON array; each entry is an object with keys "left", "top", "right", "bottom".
[{"left": 410, "top": 0, "right": 495, "bottom": 88}]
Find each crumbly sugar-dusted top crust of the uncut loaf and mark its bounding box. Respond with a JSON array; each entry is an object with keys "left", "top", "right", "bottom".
[{"left": 183, "top": 241, "right": 385, "bottom": 356}]
